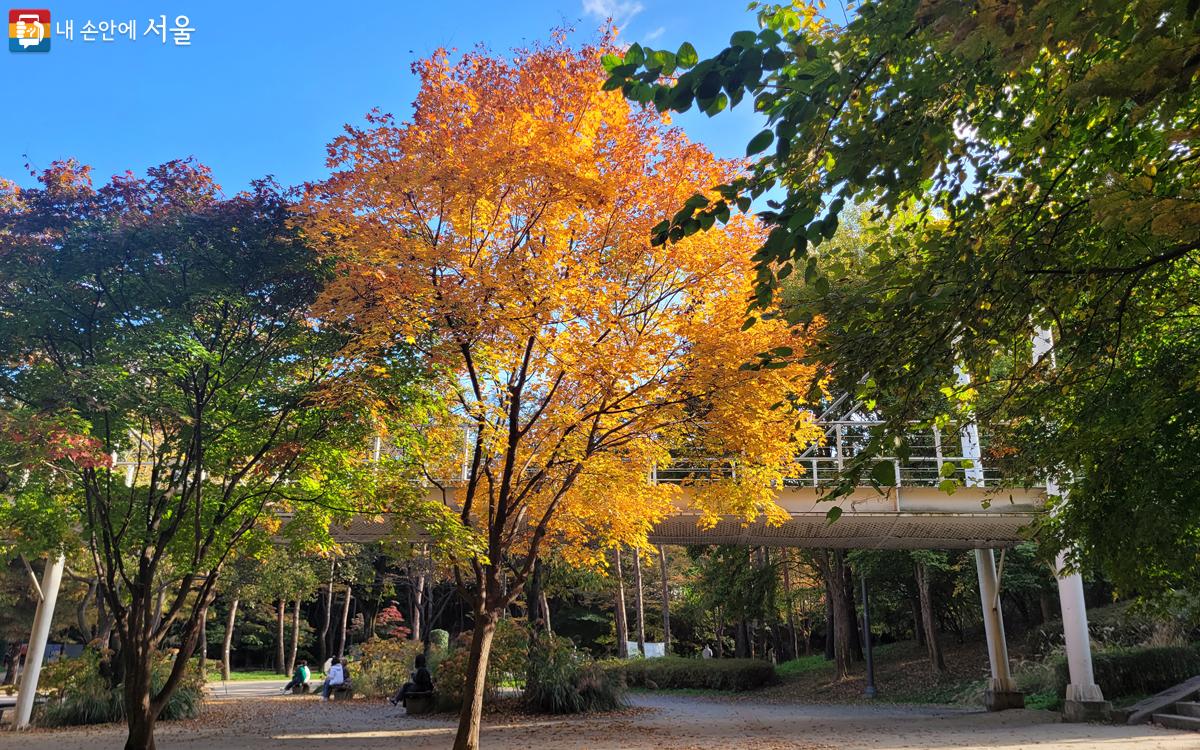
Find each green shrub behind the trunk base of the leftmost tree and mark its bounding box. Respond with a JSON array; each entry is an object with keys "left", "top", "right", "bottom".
[{"left": 38, "top": 648, "right": 204, "bottom": 726}]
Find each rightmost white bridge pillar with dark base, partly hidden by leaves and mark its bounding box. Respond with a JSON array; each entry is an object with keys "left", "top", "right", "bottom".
[{"left": 1033, "top": 326, "right": 1112, "bottom": 721}]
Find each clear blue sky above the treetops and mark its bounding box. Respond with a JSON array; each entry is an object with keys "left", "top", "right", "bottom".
[{"left": 0, "top": 0, "right": 777, "bottom": 192}]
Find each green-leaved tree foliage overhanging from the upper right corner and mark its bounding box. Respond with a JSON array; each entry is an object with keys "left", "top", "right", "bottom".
[{"left": 606, "top": 0, "right": 1200, "bottom": 588}]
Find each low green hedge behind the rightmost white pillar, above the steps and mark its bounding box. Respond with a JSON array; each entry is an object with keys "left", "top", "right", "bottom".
[{"left": 1057, "top": 646, "right": 1200, "bottom": 700}]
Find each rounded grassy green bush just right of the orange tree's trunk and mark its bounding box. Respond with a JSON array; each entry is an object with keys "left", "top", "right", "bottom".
[{"left": 524, "top": 637, "right": 625, "bottom": 714}]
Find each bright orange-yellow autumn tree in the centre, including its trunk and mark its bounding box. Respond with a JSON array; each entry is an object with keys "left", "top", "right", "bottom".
[{"left": 306, "top": 38, "right": 812, "bottom": 749}]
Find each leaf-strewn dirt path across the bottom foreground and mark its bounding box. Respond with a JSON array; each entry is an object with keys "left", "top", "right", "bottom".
[{"left": 0, "top": 694, "right": 1200, "bottom": 750}]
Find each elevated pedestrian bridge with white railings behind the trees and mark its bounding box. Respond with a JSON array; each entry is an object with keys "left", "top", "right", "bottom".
[{"left": 335, "top": 418, "right": 1046, "bottom": 550}]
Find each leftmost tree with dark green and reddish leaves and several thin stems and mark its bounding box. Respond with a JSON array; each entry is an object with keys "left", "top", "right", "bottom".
[{"left": 0, "top": 161, "right": 429, "bottom": 750}]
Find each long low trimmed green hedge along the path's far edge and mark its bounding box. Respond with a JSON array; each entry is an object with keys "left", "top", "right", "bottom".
[{"left": 605, "top": 656, "right": 779, "bottom": 690}]
